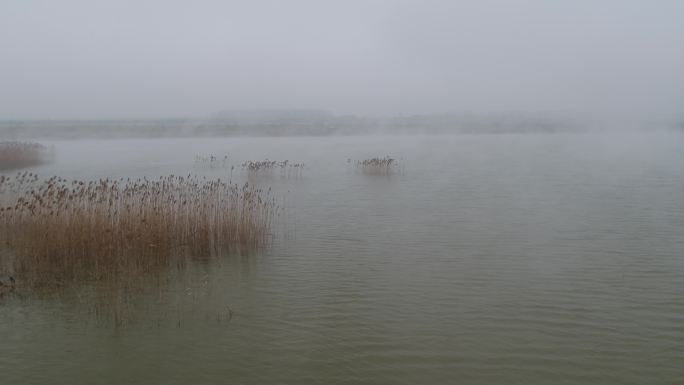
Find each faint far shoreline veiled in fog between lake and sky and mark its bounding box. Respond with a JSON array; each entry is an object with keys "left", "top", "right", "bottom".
[{"left": 0, "top": 110, "right": 684, "bottom": 140}]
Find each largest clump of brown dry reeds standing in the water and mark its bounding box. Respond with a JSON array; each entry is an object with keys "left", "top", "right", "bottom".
[{"left": 0, "top": 174, "right": 279, "bottom": 287}]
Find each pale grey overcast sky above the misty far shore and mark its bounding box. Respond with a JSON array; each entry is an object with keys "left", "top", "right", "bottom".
[{"left": 0, "top": 0, "right": 684, "bottom": 119}]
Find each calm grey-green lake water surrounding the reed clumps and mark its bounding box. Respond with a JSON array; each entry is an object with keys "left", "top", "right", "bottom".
[{"left": 0, "top": 133, "right": 684, "bottom": 384}]
